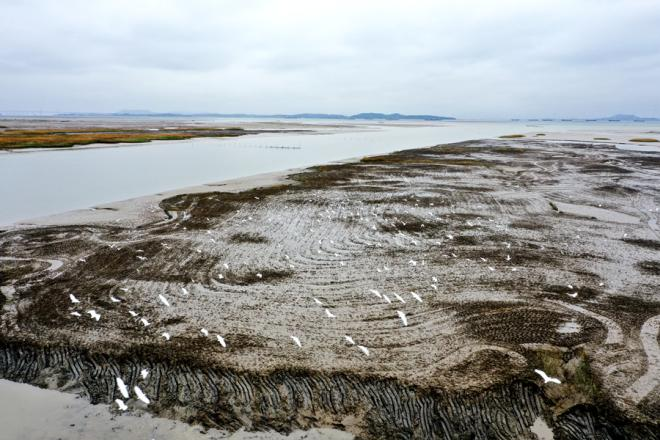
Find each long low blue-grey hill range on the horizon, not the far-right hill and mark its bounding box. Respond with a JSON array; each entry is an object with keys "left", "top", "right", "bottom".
[{"left": 58, "top": 110, "right": 456, "bottom": 121}]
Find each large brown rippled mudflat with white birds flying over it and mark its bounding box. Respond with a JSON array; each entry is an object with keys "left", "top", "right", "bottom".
[{"left": 0, "top": 141, "right": 660, "bottom": 438}]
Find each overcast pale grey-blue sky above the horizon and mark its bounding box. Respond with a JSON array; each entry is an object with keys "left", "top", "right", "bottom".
[{"left": 0, "top": 0, "right": 660, "bottom": 119}]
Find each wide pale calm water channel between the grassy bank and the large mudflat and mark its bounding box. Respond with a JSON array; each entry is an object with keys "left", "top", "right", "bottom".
[{"left": 0, "top": 118, "right": 656, "bottom": 224}]
